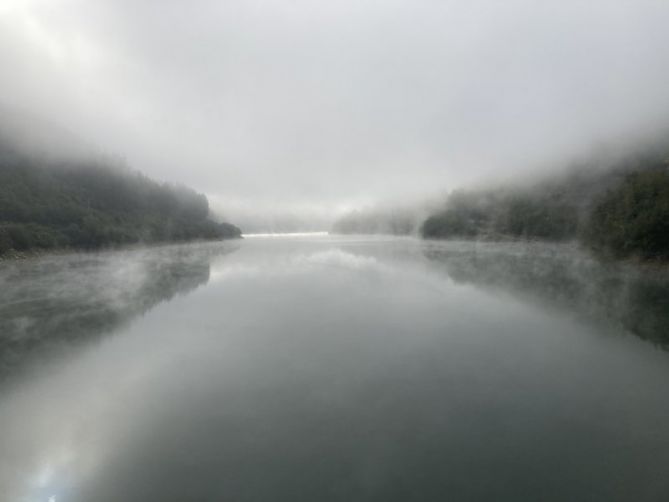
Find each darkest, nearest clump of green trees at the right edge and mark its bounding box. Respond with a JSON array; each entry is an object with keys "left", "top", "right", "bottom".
[{"left": 583, "top": 166, "right": 669, "bottom": 259}]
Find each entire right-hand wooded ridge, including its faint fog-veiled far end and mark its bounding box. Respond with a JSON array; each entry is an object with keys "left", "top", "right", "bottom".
[{"left": 332, "top": 140, "right": 669, "bottom": 260}]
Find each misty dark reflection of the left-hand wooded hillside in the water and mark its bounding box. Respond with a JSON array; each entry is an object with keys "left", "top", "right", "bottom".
[{"left": 0, "top": 243, "right": 234, "bottom": 377}]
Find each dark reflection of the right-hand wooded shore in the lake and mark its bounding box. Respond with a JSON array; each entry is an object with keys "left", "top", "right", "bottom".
[{"left": 424, "top": 242, "right": 669, "bottom": 350}]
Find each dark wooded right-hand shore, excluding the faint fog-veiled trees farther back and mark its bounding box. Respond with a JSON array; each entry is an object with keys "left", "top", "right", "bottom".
[{"left": 421, "top": 150, "right": 669, "bottom": 259}]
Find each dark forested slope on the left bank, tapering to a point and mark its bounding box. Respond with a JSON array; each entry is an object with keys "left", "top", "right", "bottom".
[{"left": 0, "top": 150, "right": 241, "bottom": 254}]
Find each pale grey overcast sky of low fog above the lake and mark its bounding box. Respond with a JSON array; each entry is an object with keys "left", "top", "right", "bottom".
[{"left": 0, "top": 0, "right": 669, "bottom": 226}]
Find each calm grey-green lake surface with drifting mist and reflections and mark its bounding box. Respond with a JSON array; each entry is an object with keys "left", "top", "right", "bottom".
[{"left": 0, "top": 237, "right": 669, "bottom": 502}]
